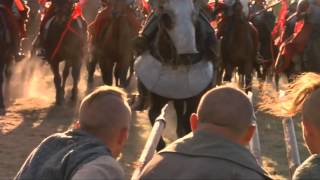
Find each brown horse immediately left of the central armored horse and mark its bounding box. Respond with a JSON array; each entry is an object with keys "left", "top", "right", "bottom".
[{"left": 93, "top": 1, "right": 140, "bottom": 87}]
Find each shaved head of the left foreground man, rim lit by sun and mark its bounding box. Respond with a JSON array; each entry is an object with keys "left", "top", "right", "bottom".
[{"left": 79, "top": 86, "right": 131, "bottom": 138}]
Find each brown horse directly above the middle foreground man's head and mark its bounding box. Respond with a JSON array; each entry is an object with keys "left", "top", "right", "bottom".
[{"left": 218, "top": 0, "right": 258, "bottom": 92}]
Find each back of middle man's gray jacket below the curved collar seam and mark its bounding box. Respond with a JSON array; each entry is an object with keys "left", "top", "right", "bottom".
[{"left": 139, "top": 153, "right": 271, "bottom": 180}]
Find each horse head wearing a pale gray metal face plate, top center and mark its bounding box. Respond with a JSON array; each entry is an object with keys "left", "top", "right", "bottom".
[{"left": 159, "top": 0, "right": 199, "bottom": 55}]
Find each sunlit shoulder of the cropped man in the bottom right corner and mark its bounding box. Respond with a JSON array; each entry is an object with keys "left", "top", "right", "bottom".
[{"left": 293, "top": 155, "right": 320, "bottom": 180}]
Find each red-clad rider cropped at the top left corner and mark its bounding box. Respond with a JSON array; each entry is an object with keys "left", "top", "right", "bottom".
[{"left": 0, "top": 0, "right": 29, "bottom": 61}]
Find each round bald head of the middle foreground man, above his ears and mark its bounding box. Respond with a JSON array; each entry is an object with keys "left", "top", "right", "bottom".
[{"left": 197, "top": 87, "right": 254, "bottom": 134}]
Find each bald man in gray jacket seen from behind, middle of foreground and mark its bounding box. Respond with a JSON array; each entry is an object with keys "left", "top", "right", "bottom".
[{"left": 140, "top": 87, "right": 270, "bottom": 180}]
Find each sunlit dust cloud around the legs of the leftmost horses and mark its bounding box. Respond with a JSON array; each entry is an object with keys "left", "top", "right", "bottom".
[{"left": 6, "top": 57, "right": 88, "bottom": 103}]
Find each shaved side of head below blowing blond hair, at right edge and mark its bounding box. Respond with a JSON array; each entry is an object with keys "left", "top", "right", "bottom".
[{"left": 302, "top": 88, "right": 320, "bottom": 128}]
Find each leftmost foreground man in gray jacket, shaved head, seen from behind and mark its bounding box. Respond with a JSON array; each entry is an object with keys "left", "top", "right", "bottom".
[{"left": 15, "top": 86, "right": 131, "bottom": 180}]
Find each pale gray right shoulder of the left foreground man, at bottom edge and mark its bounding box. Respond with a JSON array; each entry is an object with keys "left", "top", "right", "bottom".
[{"left": 71, "top": 156, "right": 125, "bottom": 180}]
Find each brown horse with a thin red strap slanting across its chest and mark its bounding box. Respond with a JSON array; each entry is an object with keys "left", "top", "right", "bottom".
[{"left": 44, "top": 3, "right": 87, "bottom": 105}]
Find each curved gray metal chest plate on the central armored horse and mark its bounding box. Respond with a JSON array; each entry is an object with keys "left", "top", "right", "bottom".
[{"left": 135, "top": 51, "right": 213, "bottom": 99}]
